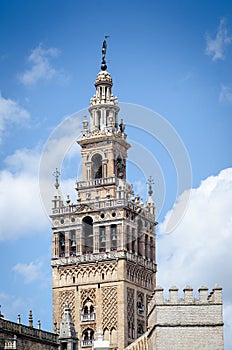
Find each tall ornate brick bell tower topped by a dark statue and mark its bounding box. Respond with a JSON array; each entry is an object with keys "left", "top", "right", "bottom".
[{"left": 51, "top": 40, "right": 157, "bottom": 350}]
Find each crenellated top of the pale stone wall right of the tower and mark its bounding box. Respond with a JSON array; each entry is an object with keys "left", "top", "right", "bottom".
[{"left": 148, "top": 285, "right": 222, "bottom": 313}]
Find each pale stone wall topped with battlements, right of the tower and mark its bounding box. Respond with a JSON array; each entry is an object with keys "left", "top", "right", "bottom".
[{"left": 148, "top": 286, "right": 224, "bottom": 350}]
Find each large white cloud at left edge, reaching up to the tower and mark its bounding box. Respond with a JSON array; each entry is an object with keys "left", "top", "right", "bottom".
[{"left": 0, "top": 113, "right": 80, "bottom": 241}]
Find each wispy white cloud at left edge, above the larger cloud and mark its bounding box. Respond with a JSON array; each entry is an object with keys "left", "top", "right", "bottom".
[{"left": 0, "top": 92, "right": 30, "bottom": 143}]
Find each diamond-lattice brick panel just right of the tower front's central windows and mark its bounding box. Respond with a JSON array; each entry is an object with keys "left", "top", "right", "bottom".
[{"left": 102, "top": 286, "right": 118, "bottom": 330}]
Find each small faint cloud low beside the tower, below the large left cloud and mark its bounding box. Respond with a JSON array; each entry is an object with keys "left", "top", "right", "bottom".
[{"left": 12, "top": 261, "right": 43, "bottom": 284}]
